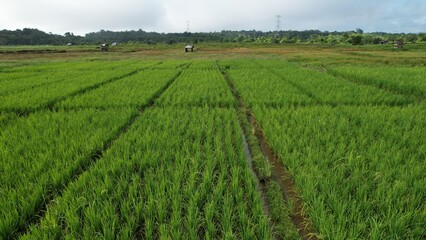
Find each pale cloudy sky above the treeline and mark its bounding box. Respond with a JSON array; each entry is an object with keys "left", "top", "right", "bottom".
[{"left": 0, "top": 0, "right": 426, "bottom": 35}]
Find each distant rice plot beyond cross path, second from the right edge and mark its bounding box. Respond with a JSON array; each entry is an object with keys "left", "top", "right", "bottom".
[{"left": 258, "top": 61, "right": 415, "bottom": 105}]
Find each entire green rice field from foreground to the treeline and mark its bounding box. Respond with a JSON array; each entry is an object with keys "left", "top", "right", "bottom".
[{"left": 0, "top": 44, "right": 426, "bottom": 239}]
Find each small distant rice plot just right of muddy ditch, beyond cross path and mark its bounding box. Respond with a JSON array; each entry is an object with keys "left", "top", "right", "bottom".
[{"left": 225, "top": 64, "right": 315, "bottom": 107}]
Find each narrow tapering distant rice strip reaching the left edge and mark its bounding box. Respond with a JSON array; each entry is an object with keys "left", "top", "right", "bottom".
[{"left": 0, "top": 62, "right": 160, "bottom": 111}]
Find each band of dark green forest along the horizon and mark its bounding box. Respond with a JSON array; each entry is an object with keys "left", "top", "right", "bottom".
[{"left": 0, "top": 28, "right": 426, "bottom": 45}]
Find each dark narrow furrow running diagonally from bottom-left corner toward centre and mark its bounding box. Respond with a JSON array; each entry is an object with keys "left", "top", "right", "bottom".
[{"left": 12, "top": 66, "right": 183, "bottom": 239}]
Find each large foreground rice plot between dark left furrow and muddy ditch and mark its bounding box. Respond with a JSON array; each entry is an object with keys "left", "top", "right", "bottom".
[{"left": 22, "top": 107, "right": 271, "bottom": 239}]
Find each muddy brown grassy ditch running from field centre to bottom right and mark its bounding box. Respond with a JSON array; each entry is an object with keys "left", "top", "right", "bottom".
[{"left": 217, "top": 64, "right": 317, "bottom": 240}]
